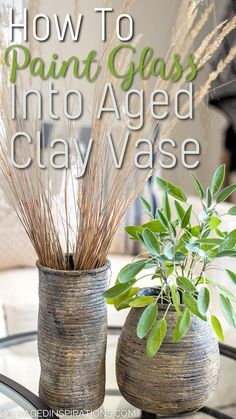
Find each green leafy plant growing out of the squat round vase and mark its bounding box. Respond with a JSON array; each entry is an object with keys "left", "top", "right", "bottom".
[{"left": 103, "top": 165, "right": 236, "bottom": 358}]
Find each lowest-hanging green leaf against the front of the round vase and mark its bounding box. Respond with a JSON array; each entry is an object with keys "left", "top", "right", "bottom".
[{"left": 146, "top": 319, "right": 167, "bottom": 358}]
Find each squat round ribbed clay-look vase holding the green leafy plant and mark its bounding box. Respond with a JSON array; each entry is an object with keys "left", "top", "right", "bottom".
[{"left": 116, "top": 305, "right": 220, "bottom": 416}]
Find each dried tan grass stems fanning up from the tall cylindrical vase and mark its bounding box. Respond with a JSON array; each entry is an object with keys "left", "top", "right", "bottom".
[{"left": 0, "top": 0, "right": 236, "bottom": 270}]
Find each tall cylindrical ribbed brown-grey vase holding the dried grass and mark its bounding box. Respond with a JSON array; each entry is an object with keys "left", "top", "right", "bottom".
[{"left": 37, "top": 263, "right": 110, "bottom": 413}]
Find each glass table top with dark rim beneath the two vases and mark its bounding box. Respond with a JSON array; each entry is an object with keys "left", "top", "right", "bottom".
[{"left": 0, "top": 331, "right": 236, "bottom": 419}]
